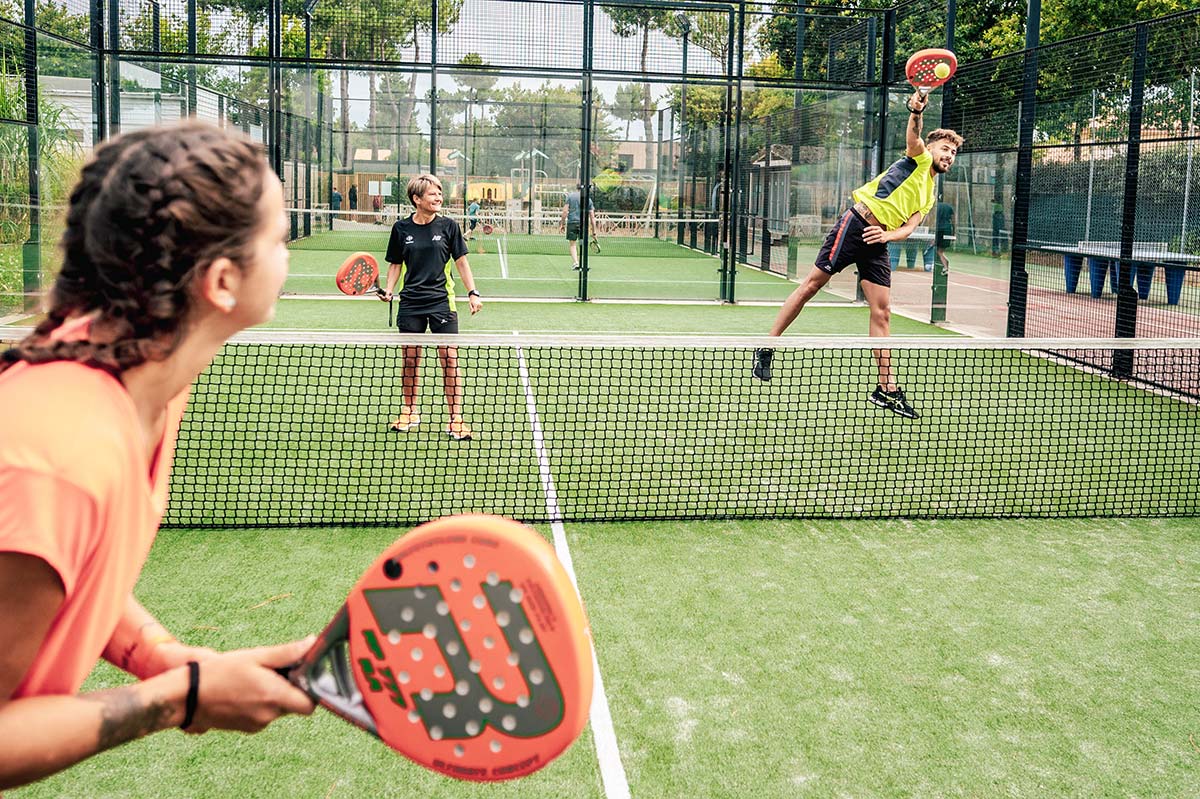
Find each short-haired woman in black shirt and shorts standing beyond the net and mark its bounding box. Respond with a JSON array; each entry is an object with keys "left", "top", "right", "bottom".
[{"left": 380, "top": 175, "right": 484, "bottom": 441}]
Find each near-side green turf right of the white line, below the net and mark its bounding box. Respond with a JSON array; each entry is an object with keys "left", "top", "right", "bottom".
[{"left": 568, "top": 519, "right": 1200, "bottom": 798}]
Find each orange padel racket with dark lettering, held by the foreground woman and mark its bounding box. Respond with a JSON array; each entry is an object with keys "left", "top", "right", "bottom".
[{"left": 278, "top": 516, "right": 592, "bottom": 781}]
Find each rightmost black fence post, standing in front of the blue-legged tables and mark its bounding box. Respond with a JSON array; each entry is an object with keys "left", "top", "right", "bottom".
[{"left": 1112, "top": 23, "right": 1150, "bottom": 378}]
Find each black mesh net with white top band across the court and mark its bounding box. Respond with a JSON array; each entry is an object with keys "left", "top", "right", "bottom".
[{"left": 96, "top": 331, "right": 1200, "bottom": 528}]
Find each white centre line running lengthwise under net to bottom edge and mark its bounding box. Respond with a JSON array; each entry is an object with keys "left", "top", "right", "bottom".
[{"left": 512, "top": 330, "right": 629, "bottom": 799}]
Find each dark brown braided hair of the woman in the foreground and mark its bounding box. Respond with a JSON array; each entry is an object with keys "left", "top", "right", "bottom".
[{"left": 0, "top": 122, "right": 266, "bottom": 376}]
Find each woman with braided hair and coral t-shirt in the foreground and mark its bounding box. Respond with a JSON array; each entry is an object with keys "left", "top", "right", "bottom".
[{"left": 0, "top": 124, "right": 313, "bottom": 789}]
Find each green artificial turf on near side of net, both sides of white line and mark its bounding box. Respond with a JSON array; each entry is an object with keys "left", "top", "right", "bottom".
[{"left": 16, "top": 519, "right": 1200, "bottom": 799}]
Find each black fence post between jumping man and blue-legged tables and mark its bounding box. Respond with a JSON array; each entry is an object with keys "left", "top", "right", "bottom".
[{"left": 1006, "top": 0, "right": 1042, "bottom": 338}]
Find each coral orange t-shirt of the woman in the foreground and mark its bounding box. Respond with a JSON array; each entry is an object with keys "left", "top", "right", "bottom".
[{"left": 0, "top": 343, "right": 187, "bottom": 698}]
